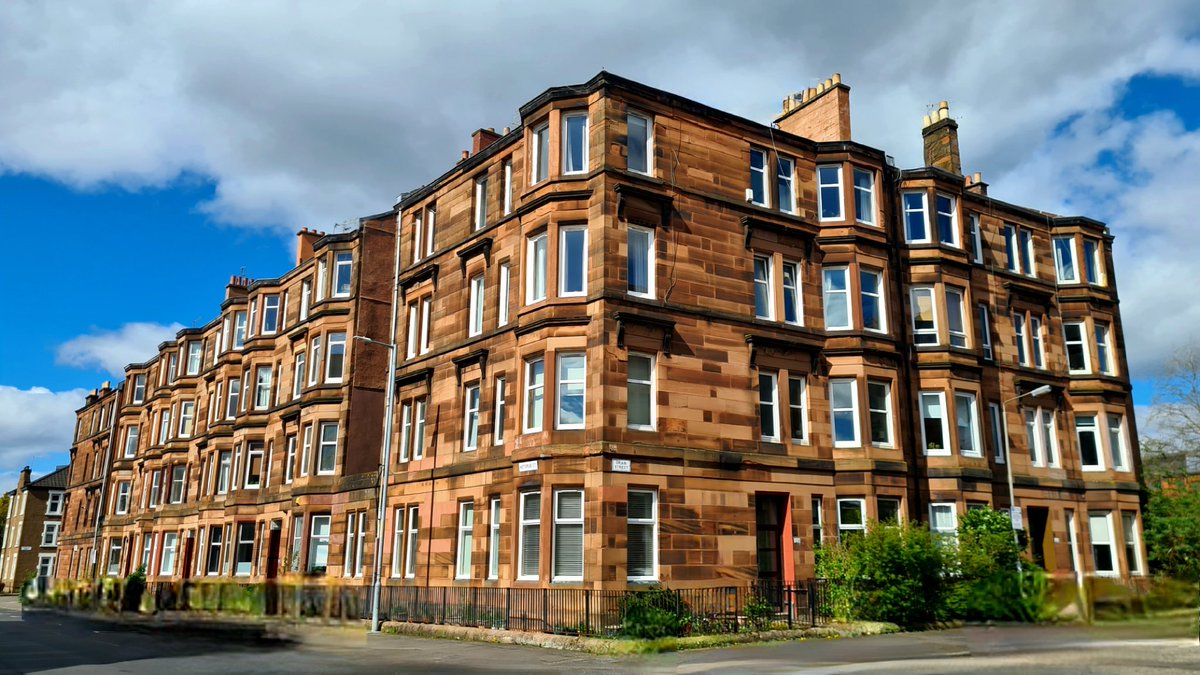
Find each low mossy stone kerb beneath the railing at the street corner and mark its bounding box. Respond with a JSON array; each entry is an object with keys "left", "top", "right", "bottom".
[{"left": 382, "top": 621, "right": 900, "bottom": 655}]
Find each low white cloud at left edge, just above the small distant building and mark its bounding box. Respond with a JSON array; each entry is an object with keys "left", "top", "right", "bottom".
[{"left": 0, "top": 384, "right": 88, "bottom": 492}]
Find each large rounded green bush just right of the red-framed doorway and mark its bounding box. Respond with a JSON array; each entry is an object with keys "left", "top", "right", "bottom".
[{"left": 817, "top": 522, "right": 943, "bottom": 628}]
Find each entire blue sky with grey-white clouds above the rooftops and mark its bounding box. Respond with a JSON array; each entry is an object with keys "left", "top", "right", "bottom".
[{"left": 0, "top": 0, "right": 1200, "bottom": 489}]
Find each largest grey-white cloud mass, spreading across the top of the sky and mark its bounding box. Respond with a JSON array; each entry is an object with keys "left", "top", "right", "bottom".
[{"left": 0, "top": 0, "right": 1200, "bottom": 372}]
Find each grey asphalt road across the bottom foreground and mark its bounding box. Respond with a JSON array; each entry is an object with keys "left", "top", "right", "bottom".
[{"left": 0, "top": 598, "right": 1200, "bottom": 675}]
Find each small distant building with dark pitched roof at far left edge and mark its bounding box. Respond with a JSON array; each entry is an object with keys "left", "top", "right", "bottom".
[{"left": 0, "top": 466, "right": 68, "bottom": 593}]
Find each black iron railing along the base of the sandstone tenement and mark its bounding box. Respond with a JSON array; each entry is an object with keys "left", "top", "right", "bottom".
[{"left": 36, "top": 579, "right": 832, "bottom": 637}]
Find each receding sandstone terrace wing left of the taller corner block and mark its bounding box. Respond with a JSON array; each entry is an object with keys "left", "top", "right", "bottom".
[{"left": 59, "top": 219, "right": 395, "bottom": 581}]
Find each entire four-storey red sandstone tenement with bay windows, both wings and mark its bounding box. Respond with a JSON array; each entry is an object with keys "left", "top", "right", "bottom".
[{"left": 60, "top": 73, "right": 1145, "bottom": 589}]
